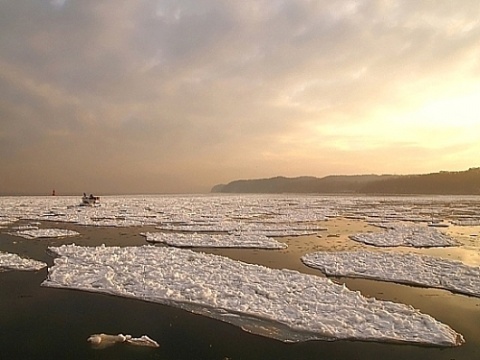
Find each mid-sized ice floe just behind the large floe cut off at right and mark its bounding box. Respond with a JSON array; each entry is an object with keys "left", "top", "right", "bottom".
[{"left": 350, "top": 223, "right": 460, "bottom": 247}]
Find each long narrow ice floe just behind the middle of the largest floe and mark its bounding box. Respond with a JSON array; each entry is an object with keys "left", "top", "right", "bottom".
[{"left": 142, "top": 232, "right": 287, "bottom": 249}]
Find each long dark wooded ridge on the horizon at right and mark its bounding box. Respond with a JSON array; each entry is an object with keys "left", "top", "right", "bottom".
[{"left": 211, "top": 168, "right": 480, "bottom": 195}]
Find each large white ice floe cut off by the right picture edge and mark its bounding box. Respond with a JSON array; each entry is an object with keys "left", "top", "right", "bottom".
[{"left": 302, "top": 251, "right": 480, "bottom": 297}]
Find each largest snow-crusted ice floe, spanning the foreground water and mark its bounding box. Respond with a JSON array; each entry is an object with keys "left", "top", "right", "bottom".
[{"left": 43, "top": 245, "right": 464, "bottom": 346}]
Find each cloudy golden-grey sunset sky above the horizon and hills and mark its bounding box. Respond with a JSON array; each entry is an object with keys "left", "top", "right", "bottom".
[{"left": 0, "top": 0, "right": 480, "bottom": 195}]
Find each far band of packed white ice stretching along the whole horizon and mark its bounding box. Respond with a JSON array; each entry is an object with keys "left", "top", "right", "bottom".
[{"left": 0, "top": 194, "right": 480, "bottom": 236}]
